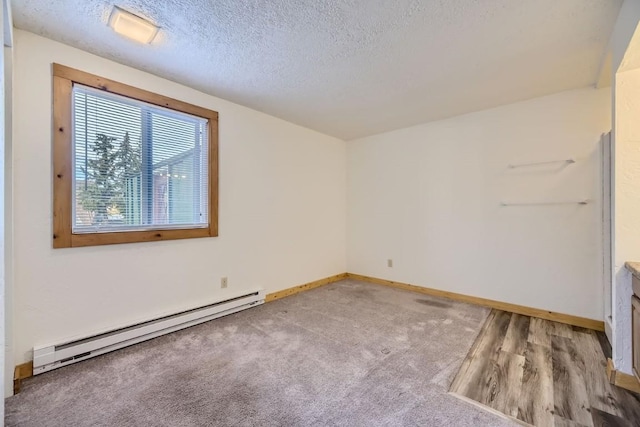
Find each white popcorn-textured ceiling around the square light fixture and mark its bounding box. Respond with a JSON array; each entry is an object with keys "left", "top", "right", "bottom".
[{"left": 12, "top": 0, "right": 622, "bottom": 139}]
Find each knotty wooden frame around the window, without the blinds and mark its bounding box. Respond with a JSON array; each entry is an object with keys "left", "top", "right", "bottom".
[{"left": 53, "top": 64, "right": 218, "bottom": 248}]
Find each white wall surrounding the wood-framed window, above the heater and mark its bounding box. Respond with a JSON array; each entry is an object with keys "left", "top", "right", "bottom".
[{"left": 8, "top": 30, "right": 346, "bottom": 370}]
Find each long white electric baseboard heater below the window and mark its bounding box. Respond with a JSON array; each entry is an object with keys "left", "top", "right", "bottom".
[{"left": 33, "top": 289, "right": 265, "bottom": 375}]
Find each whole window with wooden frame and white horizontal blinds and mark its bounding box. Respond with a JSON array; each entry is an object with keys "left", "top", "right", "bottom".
[{"left": 53, "top": 64, "right": 218, "bottom": 248}]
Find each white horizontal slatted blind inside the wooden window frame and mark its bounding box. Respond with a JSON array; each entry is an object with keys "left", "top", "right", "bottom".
[{"left": 72, "top": 84, "right": 209, "bottom": 233}]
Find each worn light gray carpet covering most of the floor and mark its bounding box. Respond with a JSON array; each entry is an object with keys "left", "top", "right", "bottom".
[{"left": 5, "top": 280, "right": 513, "bottom": 426}]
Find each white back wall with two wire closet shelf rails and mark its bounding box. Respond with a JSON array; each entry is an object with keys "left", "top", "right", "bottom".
[{"left": 347, "top": 89, "right": 611, "bottom": 320}]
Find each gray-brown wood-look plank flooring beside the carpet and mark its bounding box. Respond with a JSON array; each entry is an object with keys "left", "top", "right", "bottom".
[{"left": 450, "top": 310, "right": 640, "bottom": 427}]
